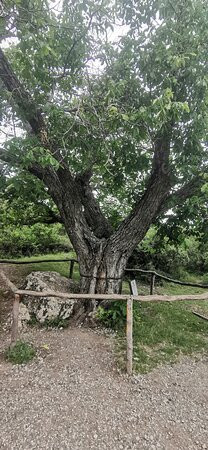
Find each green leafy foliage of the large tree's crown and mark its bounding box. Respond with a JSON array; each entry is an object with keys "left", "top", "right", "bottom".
[{"left": 2, "top": 0, "right": 207, "bottom": 213}]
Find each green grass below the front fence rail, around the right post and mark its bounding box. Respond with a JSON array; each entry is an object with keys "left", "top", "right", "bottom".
[{"left": 117, "top": 301, "right": 208, "bottom": 373}]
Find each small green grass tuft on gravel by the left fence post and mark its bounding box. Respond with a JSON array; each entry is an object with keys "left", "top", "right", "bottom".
[{"left": 5, "top": 341, "right": 36, "bottom": 364}]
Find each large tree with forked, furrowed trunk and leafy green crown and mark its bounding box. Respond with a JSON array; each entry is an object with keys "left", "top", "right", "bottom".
[{"left": 0, "top": 0, "right": 208, "bottom": 293}]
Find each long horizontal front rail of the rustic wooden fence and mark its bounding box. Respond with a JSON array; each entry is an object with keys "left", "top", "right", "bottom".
[{"left": 16, "top": 289, "right": 208, "bottom": 302}]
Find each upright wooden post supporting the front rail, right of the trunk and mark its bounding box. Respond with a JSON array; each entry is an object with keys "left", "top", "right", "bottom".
[{"left": 126, "top": 297, "right": 133, "bottom": 375}]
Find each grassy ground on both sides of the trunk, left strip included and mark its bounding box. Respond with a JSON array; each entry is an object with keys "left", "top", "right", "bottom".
[{"left": 2, "top": 252, "right": 208, "bottom": 372}]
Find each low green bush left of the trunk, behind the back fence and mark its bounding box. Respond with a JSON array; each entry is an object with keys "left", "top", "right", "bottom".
[{"left": 0, "top": 223, "right": 70, "bottom": 258}]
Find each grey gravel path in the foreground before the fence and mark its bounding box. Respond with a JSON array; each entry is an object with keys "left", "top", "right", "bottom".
[{"left": 0, "top": 328, "right": 208, "bottom": 450}]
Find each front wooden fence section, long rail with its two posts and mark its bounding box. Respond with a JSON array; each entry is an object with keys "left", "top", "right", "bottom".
[{"left": 0, "top": 271, "right": 208, "bottom": 375}]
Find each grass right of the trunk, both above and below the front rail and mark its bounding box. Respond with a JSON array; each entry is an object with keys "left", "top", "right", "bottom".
[{"left": 98, "top": 274, "right": 208, "bottom": 373}]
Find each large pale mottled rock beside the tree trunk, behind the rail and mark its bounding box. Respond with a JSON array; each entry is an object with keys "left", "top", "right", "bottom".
[{"left": 19, "top": 272, "right": 79, "bottom": 328}]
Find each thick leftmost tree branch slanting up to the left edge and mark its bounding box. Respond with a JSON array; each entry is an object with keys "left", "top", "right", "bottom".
[{"left": 0, "top": 50, "right": 102, "bottom": 257}]
